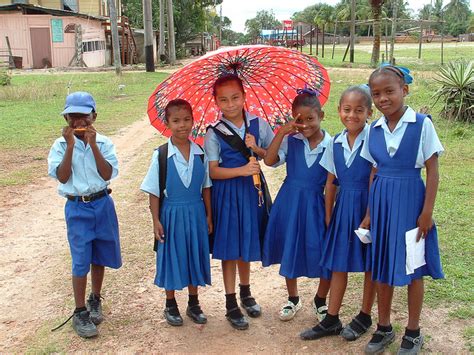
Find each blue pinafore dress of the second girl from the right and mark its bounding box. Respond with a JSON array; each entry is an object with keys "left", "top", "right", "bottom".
[{"left": 321, "top": 136, "right": 372, "bottom": 272}]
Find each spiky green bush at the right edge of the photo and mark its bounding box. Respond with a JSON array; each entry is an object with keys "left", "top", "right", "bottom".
[{"left": 433, "top": 60, "right": 474, "bottom": 123}]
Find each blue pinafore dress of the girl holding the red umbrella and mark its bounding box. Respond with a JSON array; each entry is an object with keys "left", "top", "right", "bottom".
[{"left": 212, "top": 119, "right": 266, "bottom": 262}]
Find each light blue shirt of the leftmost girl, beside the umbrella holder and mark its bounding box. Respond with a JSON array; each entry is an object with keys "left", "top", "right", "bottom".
[{"left": 140, "top": 138, "right": 212, "bottom": 197}]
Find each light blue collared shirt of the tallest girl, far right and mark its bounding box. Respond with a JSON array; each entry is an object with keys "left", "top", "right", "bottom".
[{"left": 360, "top": 107, "right": 444, "bottom": 168}]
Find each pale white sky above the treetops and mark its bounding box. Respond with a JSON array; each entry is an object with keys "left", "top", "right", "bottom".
[{"left": 222, "top": 0, "right": 474, "bottom": 32}]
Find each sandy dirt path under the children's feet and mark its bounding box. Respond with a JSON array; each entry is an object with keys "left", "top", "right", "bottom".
[{"left": 0, "top": 114, "right": 465, "bottom": 353}]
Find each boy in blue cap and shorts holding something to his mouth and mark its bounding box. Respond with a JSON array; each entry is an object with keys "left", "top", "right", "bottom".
[{"left": 48, "top": 92, "right": 122, "bottom": 338}]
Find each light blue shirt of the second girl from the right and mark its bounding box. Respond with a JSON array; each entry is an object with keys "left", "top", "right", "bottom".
[{"left": 319, "top": 124, "right": 370, "bottom": 177}]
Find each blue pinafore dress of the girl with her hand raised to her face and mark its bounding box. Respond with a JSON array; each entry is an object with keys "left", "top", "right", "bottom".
[{"left": 263, "top": 136, "right": 331, "bottom": 279}]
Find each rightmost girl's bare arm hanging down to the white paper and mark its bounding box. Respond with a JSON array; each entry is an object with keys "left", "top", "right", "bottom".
[{"left": 418, "top": 154, "right": 439, "bottom": 240}]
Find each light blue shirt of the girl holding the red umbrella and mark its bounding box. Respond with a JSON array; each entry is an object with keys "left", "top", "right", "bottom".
[{"left": 204, "top": 112, "right": 274, "bottom": 162}]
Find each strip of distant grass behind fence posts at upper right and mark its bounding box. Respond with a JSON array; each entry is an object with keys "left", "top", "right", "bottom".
[{"left": 303, "top": 42, "right": 474, "bottom": 71}]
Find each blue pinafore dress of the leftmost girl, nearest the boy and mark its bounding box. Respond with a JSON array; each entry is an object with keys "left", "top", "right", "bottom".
[{"left": 155, "top": 155, "right": 211, "bottom": 290}]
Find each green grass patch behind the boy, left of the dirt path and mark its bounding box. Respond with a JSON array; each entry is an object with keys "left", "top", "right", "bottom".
[{"left": 0, "top": 72, "right": 167, "bottom": 150}]
